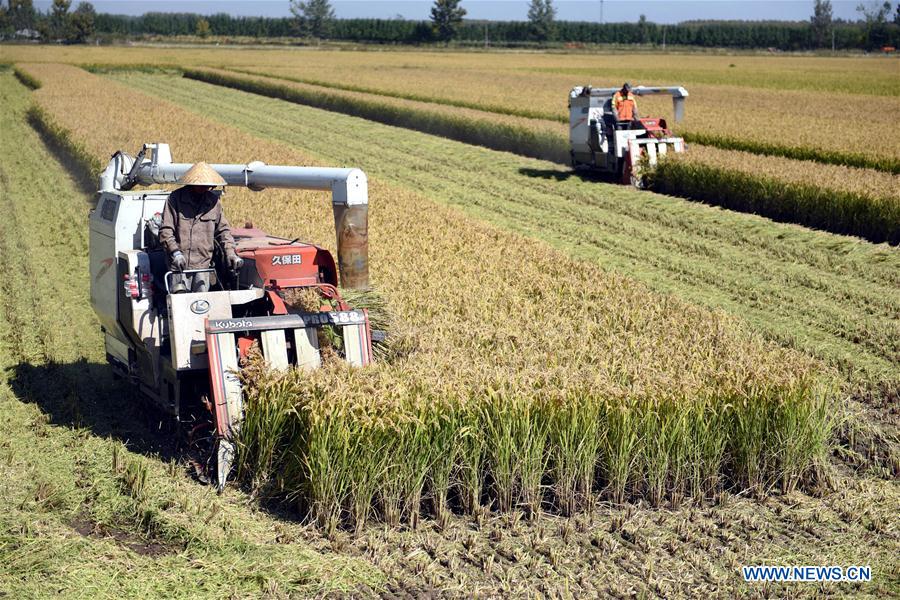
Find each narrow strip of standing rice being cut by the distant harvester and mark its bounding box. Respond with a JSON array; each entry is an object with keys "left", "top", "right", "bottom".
[{"left": 185, "top": 69, "right": 900, "bottom": 244}]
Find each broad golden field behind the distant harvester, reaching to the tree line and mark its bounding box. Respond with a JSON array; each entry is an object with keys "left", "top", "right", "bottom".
[{"left": 4, "top": 46, "right": 900, "bottom": 164}]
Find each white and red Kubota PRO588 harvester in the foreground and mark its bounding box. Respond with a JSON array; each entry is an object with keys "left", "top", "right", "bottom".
[{"left": 90, "top": 144, "right": 372, "bottom": 489}]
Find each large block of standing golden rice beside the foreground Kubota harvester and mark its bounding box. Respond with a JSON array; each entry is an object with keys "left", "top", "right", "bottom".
[{"left": 24, "top": 65, "right": 831, "bottom": 530}]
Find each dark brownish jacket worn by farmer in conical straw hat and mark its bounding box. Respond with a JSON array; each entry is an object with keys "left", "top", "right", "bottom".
[{"left": 159, "top": 187, "right": 234, "bottom": 269}]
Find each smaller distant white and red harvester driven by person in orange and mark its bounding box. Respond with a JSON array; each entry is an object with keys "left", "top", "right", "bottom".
[{"left": 569, "top": 86, "right": 688, "bottom": 187}]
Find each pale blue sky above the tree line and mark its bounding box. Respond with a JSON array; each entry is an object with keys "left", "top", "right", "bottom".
[{"left": 35, "top": 0, "right": 873, "bottom": 23}]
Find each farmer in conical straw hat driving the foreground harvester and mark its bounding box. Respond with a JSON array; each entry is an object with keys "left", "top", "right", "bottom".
[{"left": 159, "top": 162, "right": 244, "bottom": 293}]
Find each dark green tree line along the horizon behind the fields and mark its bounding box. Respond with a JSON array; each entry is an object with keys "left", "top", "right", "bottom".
[{"left": 0, "top": 0, "right": 900, "bottom": 50}]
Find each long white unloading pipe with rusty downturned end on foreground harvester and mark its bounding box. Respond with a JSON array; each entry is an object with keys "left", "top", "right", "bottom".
[{"left": 100, "top": 144, "right": 369, "bottom": 289}]
